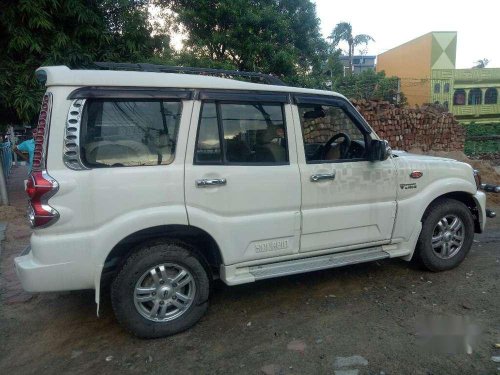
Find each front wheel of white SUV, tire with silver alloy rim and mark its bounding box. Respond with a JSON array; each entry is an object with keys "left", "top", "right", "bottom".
[{"left": 415, "top": 199, "right": 474, "bottom": 272}]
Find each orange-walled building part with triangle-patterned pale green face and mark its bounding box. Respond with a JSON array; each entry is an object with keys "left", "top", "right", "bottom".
[{"left": 377, "top": 31, "right": 457, "bottom": 105}]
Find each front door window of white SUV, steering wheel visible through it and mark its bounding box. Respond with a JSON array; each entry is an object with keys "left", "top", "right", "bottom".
[{"left": 299, "top": 104, "right": 366, "bottom": 163}]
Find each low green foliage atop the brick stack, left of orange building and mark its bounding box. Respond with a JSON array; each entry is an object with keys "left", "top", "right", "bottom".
[{"left": 333, "top": 70, "right": 406, "bottom": 104}]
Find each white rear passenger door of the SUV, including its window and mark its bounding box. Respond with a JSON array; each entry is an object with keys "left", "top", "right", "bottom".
[{"left": 185, "top": 92, "right": 301, "bottom": 265}]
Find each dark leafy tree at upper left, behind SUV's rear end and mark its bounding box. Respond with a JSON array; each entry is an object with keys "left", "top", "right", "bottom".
[{"left": 0, "top": 0, "right": 170, "bottom": 124}]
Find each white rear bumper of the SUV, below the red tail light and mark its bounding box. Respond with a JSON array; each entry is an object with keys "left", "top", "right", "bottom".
[{"left": 14, "top": 246, "right": 94, "bottom": 292}]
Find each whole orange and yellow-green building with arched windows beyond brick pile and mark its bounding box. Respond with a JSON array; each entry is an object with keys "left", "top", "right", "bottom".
[{"left": 377, "top": 31, "right": 500, "bottom": 124}]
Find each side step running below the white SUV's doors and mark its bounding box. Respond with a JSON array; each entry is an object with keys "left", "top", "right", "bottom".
[{"left": 248, "top": 246, "right": 389, "bottom": 280}]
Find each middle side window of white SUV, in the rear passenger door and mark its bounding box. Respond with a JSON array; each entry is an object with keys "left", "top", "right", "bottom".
[{"left": 195, "top": 102, "right": 288, "bottom": 164}]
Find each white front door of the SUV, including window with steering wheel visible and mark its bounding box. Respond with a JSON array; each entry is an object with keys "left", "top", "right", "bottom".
[{"left": 293, "top": 95, "right": 396, "bottom": 252}]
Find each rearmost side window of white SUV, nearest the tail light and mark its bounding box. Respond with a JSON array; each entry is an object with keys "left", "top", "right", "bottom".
[{"left": 81, "top": 99, "right": 182, "bottom": 168}]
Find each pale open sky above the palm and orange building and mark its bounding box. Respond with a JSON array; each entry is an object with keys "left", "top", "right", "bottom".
[{"left": 314, "top": 0, "right": 500, "bottom": 68}]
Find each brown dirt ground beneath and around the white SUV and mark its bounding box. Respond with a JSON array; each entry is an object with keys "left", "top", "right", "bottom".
[{"left": 0, "top": 162, "right": 500, "bottom": 375}]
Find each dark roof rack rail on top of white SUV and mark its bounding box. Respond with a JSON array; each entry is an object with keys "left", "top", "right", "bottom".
[{"left": 93, "top": 62, "right": 286, "bottom": 86}]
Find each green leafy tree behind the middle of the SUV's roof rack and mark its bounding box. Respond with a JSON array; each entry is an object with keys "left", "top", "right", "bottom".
[{"left": 158, "top": 0, "right": 327, "bottom": 85}]
